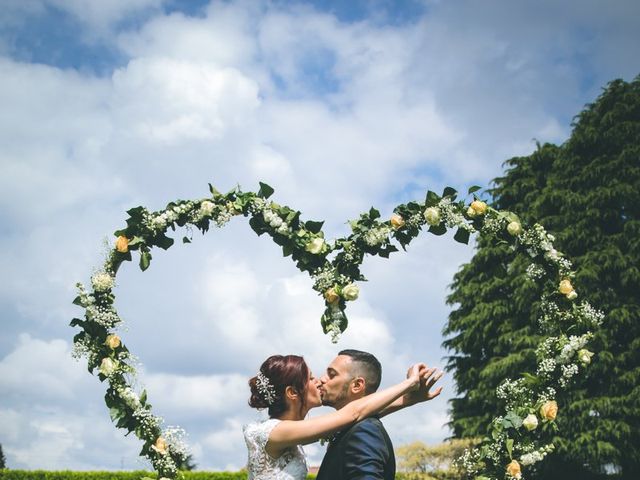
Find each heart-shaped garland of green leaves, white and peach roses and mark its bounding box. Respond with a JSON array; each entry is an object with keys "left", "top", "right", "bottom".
[{"left": 71, "top": 183, "right": 603, "bottom": 480}]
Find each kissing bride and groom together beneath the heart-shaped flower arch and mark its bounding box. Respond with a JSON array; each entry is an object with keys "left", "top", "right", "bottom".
[{"left": 243, "top": 350, "right": 442, "bottom": 480}]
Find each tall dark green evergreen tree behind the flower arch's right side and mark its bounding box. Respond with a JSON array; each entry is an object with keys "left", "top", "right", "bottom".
[{"left": 444, "top": 77, "right": 640, "bottom": 479}]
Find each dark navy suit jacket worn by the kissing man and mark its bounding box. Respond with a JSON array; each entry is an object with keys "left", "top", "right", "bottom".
[{"left": 317, "top": 417, "right": 396, "bottom": 480}]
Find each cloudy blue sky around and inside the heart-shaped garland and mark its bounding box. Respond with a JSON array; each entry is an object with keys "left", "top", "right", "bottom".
[{"left": 0, "top": 0, "right": 640, "bottom": 469}]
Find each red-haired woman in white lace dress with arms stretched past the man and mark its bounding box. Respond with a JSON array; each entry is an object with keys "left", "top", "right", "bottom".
[{"left": 243, "top": 355, "right": 439, "bottom": 480}]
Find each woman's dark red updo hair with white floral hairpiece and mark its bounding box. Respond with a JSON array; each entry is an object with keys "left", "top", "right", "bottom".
[{"left": 249, "top": 355, "right": 309, "bottom": 418}]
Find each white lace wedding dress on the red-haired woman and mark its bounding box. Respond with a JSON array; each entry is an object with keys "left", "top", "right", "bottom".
[{"left": 242, "top": 418, "right": 309, "bottom": 480}]
